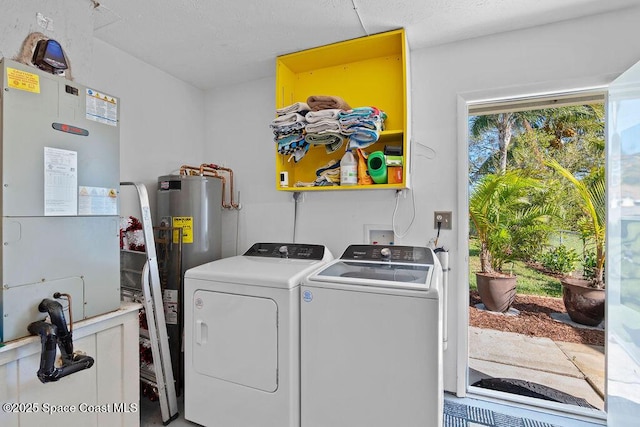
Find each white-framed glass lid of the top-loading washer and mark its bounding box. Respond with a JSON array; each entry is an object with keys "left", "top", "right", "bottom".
[{"left": 309, "top": 259, "right": 434, "bottom": 291}]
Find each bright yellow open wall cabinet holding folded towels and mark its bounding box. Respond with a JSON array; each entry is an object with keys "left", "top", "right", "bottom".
[{"left": 274, "top": 29, "right": 410, "bottom": 191}]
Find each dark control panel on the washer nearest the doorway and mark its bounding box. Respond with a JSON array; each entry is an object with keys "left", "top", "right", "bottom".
[{"left": 340, "top": 245, "right": 433, "bottom": 264}]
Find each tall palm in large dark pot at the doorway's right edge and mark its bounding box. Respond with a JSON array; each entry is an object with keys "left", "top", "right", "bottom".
[{"left": 545, "top": 160, "right": 606, "bottom": 326}]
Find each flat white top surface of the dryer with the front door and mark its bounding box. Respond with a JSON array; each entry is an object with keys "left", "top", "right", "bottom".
[{"left": 185, "top": 243, "right": 333, "bottom": 289}]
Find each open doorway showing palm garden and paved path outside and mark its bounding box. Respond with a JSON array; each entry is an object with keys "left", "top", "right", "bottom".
[{"left": 468, "top": 92, "right": 606, "bottom": 412}]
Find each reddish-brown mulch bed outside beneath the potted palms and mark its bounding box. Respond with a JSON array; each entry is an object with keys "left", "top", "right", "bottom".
[{"left": 469, "top": 291, "right": 604, "bottom": 346}]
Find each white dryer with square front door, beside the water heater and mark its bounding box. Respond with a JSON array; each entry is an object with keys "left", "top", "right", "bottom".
[{"left": 184, "top": 243, "right": 333, "bottom": 427}]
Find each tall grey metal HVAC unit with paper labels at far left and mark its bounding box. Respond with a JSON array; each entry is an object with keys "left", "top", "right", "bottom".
[{"left": 0, "top": 59, "right": 120, "bottom": 342}]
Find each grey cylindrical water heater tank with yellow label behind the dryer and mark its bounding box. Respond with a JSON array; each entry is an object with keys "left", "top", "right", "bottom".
[{"left": 157, "top": 175, "right": 222, "bottom": 273}]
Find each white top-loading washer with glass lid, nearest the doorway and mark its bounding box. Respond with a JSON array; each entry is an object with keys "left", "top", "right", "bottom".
[{"left": 300, "top": 245, "right": 444, "bottom": 427}]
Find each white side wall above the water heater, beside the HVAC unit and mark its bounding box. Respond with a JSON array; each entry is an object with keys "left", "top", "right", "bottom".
[{"left": 90, "top": 39, "right": 206, "bottom": 216}]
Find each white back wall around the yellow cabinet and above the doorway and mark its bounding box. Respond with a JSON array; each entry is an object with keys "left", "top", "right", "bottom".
[{"left": 205, "top": 9, "right": 640, "bottom": 390}]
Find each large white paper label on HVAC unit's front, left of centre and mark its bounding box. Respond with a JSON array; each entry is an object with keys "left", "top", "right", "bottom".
[{"left": 44, "top": 147, "right": 78, "bottom": 216}]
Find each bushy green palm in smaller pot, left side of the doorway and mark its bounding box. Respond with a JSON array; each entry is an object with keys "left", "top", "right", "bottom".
[{"left": 469, "top": 171, "right": 553, "bottom": 312}]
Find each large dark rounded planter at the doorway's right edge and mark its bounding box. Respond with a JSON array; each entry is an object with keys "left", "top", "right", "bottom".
[{"left": 560, "top": 278, "right": 605, "bottom": 326}]
